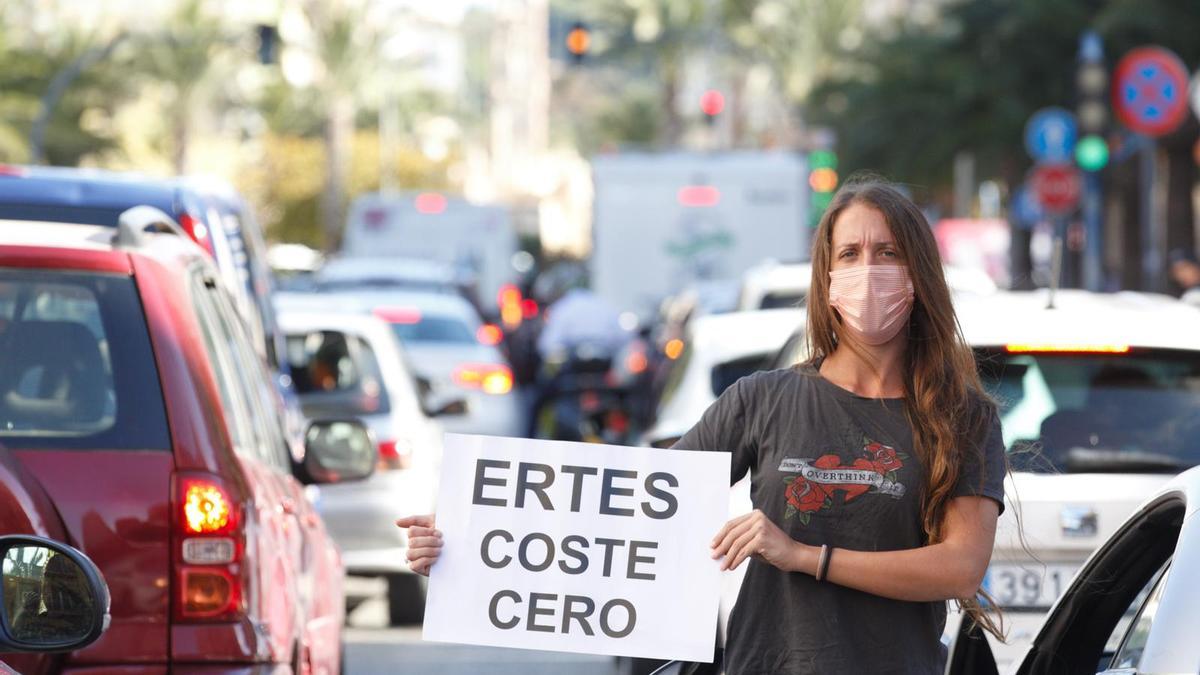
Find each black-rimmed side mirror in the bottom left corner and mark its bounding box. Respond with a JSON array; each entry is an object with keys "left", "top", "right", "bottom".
[{"left": 0, "top": 534, "right": 109, "bottom": 652}]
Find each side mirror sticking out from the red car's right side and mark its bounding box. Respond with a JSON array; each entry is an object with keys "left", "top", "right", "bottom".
[{"left": 304, "top": 419, "right": 378, "bottom": 483}]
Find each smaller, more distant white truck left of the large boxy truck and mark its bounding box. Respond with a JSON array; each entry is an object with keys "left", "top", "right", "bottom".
[{"left": 342, "top": 192, "right": 517, "bottom": 306}]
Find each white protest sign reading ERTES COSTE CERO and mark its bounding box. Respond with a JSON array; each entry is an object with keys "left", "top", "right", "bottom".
[{"left": 424, "top": 434, "right": 730, "bottom": 662}]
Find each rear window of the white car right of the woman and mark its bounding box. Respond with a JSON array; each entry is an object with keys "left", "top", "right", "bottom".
[{"left": 977, "top": 350, "right": 1200, "bottom": 473}]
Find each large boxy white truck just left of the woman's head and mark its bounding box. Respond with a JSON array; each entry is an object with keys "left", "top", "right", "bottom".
[{"left": 590, "top": 151, "right": 810, "bottom": 316}]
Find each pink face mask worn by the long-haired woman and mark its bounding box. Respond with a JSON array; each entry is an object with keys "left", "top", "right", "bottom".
[{"left": 829, "top": 264, "right": 913, "bottom": 346}]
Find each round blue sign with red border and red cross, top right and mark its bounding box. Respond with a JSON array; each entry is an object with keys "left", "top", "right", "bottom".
[{"left": 1112, "top": 47, "right": 1188, "bottom": 136}]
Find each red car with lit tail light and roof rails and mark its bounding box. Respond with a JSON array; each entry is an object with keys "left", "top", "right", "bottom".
[{"left": 0, "top": 207, "right": 376, "bottom": 675}]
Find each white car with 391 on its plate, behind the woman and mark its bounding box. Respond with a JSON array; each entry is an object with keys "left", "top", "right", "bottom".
[{"left": 774, "top": 285, "right": 1200, "bottom": 664}]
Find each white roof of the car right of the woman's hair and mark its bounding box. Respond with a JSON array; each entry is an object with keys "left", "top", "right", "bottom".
[{"left": 955, "top": 289, "right": 1200, "bottom": 351}]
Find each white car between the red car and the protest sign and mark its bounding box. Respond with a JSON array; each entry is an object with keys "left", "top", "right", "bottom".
[{"left": 278, "top": 311, "right": 443, "bottom": 625}]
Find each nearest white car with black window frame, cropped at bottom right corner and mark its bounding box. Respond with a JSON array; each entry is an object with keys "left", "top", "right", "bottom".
[{"left": 654, "top": 461, "right": 1200, "bottom": 675}]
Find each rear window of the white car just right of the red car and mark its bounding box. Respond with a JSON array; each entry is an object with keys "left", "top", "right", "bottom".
[{"left": 288, "top": 330, "right": 390, "bottom": 417}]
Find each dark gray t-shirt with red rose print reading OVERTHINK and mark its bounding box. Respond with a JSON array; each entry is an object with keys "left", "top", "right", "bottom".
[{"left": 674, "top": 365, "right": 1004, "bottom": 675}]
